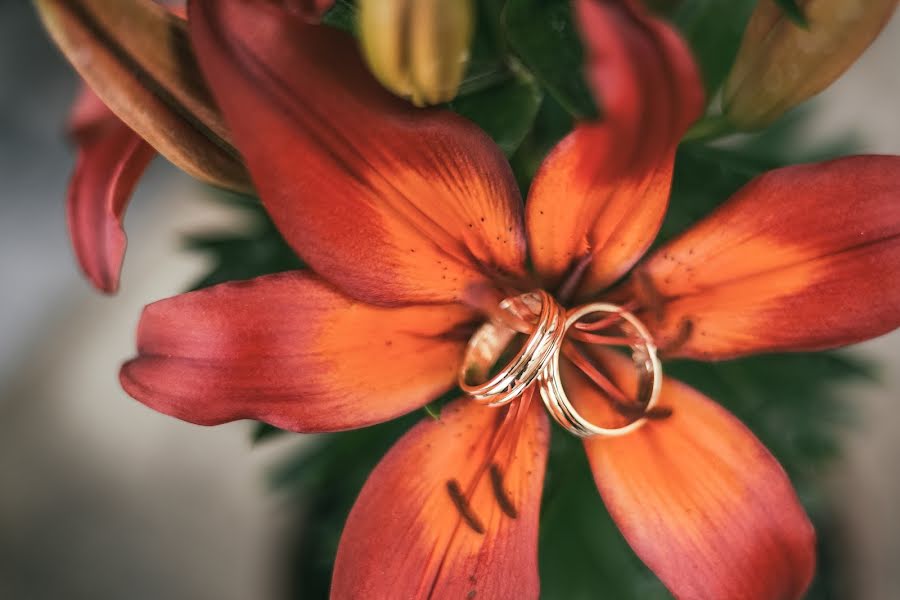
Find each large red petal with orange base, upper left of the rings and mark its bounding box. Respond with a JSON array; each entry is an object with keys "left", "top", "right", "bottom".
[{"left": 190, "top": 0, "right": 525, "bottom": 304}]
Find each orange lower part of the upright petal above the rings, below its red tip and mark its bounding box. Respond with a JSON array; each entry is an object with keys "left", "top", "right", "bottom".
[{"left": 527, "top": 130, "right": 674, "bottom": 297}]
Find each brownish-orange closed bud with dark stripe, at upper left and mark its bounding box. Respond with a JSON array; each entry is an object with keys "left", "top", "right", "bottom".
[{"left": 35, "top": 0, "right": 250, "bottom": 191}]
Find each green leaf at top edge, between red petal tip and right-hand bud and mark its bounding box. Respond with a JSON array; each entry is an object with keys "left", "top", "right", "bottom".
[{"left": 674, "top": 0, "right": 756, "bottom": 97}]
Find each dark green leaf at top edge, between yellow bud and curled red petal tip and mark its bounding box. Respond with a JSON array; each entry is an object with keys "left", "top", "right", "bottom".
[{"left": 503, "top": 0, "right": 599, "bottom": 119}]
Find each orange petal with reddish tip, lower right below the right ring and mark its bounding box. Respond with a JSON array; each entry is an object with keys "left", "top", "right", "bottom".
[{"left": 563, "top": 351, "right": 815, "bottom": 600}]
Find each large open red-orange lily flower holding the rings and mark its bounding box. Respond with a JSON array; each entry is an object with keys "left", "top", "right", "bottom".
[{"left": 121, "top": 0, "right": 900, "bottom": 600}]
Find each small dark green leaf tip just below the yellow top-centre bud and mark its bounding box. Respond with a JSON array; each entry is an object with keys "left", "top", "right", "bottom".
[{"left": 450, "top": 69, "right": 541, "bottom": 156}]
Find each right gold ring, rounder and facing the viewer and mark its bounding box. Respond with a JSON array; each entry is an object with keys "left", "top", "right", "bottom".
[{"left": 540, "top": 302, "right": 662, "bottom": 437}]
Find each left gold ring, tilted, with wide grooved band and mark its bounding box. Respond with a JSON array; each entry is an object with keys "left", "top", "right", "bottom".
[{"left": 459, "top": 290, "right": 566, "bottom": 406}]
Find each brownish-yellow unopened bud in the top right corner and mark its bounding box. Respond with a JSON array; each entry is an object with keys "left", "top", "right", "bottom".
[{"left": 723, "top": 0, "right": 897, "bottom": 130}]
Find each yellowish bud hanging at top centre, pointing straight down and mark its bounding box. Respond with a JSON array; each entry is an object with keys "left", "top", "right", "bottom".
[{"left": 358, "top": 0, "right": 474, "bottom": 106}]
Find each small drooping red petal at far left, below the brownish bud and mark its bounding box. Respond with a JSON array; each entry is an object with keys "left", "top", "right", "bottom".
[{"left": 66, "top": 88, "right": 156, "bottom": 294}]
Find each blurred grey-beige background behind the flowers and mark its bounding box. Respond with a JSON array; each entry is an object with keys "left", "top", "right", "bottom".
[{"left": 0, "top": 0, "right": 900, "bottom": 600}]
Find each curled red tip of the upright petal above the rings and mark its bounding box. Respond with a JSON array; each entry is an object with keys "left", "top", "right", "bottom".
[{"left": 575, "top": 0, "right": 704, "bottom": 180}]
